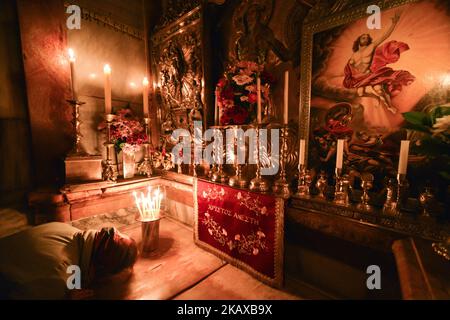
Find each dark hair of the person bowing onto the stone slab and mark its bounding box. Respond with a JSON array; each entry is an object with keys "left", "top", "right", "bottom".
[{"left": 91, "top": 228, "right": 138, "bottom": 277}]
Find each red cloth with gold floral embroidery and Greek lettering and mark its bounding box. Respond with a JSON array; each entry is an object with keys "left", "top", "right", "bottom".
[{"left": 194, "top": 180, "right": 284, "bottom": 286}]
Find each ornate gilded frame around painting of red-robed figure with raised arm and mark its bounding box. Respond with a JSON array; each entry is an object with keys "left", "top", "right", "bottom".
[{"left": 299, "top": 0, "right": 420, "bottom": 165}]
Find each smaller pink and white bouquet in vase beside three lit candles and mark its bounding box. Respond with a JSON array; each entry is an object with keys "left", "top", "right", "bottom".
[{"left": 99, "top": 107, "right": 147, "bottom": 154}]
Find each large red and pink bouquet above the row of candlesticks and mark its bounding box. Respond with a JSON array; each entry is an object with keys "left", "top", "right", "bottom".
[{"left": 217, "top": 61, "right": 274, "bottom": 125}]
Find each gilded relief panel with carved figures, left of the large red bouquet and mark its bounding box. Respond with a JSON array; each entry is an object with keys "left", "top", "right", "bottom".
[{"left": 152, "top": 7, "right": 204, "bottom": 145}]
